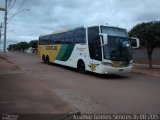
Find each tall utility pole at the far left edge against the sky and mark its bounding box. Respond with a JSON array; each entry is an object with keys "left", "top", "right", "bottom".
[{"left": 3, "top": 0, "right": 8, "bottom": 55}]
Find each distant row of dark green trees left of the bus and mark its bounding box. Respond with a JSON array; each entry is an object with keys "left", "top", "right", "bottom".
[{"left": 7, "top": 40, "right": 38, "bottom": 52}]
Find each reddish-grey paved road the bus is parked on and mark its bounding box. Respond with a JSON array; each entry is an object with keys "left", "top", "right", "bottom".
[{"left": 5, "top": 53, "right": 160, "bottom": 113}]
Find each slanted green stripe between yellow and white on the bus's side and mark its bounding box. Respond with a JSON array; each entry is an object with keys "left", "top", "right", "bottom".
[{"left": 56, "top": 44, "right": 75, "bottom": 61}]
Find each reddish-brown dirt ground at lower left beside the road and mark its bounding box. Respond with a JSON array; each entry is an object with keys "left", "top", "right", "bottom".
[{"left": 0, "top": 56, "right": 74, "bottom": 114}]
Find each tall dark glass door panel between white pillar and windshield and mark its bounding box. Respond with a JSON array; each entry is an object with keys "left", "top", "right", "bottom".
[{"left": 88, "top": 27, "right": 102, "bottom": 61}]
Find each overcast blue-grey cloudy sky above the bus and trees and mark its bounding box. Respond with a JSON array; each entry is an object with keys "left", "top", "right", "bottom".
[{"left": 0, "top": 0, "right": 160, "bottom": 48}]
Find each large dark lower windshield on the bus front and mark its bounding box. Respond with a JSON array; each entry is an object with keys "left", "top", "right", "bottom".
[{"left": 103, "top": 35, "right": 132, "bottom": 63}]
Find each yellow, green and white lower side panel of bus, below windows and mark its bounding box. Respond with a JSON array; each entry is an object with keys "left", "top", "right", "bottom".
[{"left": 39, "top": 44, "right": 102, "bottom": 73}]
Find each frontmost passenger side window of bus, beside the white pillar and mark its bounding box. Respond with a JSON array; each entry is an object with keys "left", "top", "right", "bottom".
[{"left": 75, "top": 28, "right": 86, "bottom": 43}]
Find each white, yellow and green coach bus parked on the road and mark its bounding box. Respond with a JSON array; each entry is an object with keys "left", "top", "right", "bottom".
[{"left": 38, "top": 25, "right": 139, "bottom": 74}]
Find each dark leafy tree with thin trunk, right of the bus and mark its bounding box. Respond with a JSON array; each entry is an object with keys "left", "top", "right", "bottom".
[{"left": 129, "top": 21, "right": 160, "bottom": 68}]
